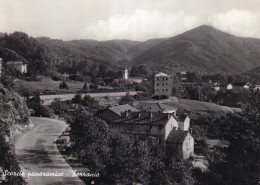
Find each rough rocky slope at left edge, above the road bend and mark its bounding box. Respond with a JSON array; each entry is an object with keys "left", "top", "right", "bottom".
[{"left": 0, "top": 84, "right": 33, "bottom": 139}]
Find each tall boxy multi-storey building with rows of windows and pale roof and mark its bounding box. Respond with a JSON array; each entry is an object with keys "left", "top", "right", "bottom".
[{"left": 154, "top": 72, "right": 172, "bottom": 97}]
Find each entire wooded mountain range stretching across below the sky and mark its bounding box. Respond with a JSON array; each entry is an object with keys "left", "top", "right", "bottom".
[{"left": 0, "top": 25, "right": 260, "bottom": 74}]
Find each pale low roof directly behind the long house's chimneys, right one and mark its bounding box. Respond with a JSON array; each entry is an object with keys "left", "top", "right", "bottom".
[{"left": 136, "top": 102, "right": 177, "bottom": 112}]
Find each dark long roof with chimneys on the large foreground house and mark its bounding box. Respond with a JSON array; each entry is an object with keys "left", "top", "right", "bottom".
[{"left": 108, "top": 112, "right": 169, "bottom": 126}]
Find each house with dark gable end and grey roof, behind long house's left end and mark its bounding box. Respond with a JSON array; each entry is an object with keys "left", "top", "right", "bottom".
[{"left": 96, "top": 104, "right": 139, "bottom": 120}]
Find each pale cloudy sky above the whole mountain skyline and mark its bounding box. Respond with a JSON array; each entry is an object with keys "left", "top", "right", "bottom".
[{"left": 0, "top": 0, "right": 260, "bottom": 41}]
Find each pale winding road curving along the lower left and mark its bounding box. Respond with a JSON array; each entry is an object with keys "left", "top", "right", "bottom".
[{"left": 15, "top": 117, "right": 85, "bottom": 185}]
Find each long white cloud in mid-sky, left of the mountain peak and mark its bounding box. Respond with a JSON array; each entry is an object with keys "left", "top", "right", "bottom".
[{"left": 81, "top": 9, "right": 198, "bottom": 40}]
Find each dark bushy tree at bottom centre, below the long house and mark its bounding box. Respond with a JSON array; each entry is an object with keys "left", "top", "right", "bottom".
[{"left": 106, "top": 134, "right": 151, "bottom": 184}]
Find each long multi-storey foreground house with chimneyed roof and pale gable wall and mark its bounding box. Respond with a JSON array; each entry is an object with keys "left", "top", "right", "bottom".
[{"left": 99, "top": 111, "right": 194, "bottom": 156}]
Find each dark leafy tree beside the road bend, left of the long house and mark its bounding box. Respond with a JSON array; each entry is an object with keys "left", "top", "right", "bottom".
[{"left": 70, "top": 112, "right": 109, "bottom": 172}]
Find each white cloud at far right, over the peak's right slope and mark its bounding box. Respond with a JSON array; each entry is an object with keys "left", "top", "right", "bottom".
[{"left": 209, "top": 9, "right": 260, "bottom": 37}]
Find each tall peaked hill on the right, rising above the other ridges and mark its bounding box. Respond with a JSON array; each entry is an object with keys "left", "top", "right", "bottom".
[{"left": 133, "top": 25, "right": 260, "bottom": 74}]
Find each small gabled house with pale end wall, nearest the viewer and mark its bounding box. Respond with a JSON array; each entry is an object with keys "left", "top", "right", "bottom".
[{"left": 166, "top": 130, "right": 194, "bottom": 159}]
